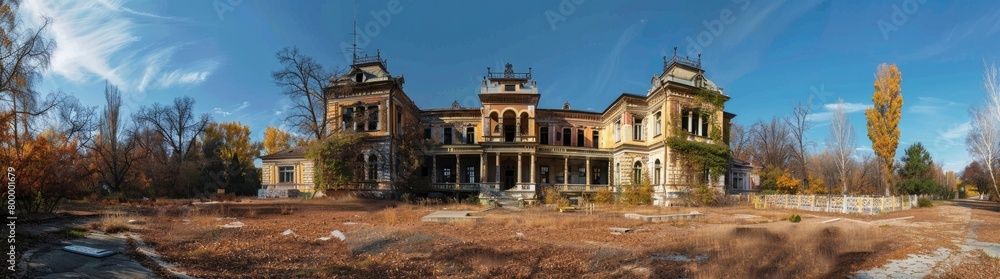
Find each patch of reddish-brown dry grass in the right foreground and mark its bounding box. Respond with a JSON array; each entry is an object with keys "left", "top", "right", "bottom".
[{"left": 652, "top": 225, "right": 890, "bottom": 278}]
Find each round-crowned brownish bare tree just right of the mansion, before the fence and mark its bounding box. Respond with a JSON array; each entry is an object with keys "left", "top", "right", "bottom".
[{"left": 750, "top": 117, "right": 794, "bottom": 169}]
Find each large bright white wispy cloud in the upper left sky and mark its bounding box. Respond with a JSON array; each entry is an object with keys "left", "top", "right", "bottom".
[{"left": 21, "top": 0, "right": 219, "bottom": 92}]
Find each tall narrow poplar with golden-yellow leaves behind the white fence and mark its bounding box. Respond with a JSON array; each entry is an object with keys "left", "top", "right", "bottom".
[{"left": 865, "top": 63, "right": 903, "bottom": 195}]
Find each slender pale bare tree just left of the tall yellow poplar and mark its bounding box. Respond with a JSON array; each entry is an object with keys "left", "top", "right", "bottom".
[{"left": 826, "top": 99, "right": 857, "bottom": 194}]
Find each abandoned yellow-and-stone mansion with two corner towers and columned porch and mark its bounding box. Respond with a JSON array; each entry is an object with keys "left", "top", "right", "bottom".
[{"left": 261, "top": 49, "right": 754, "bottom": 204}]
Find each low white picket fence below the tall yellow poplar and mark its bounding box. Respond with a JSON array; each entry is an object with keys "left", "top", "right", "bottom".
[{"left": 749, "top": 194, "right": 920, "bottom": 214}]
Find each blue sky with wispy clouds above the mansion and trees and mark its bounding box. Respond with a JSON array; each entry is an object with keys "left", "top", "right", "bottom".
[{"left": 21, "top": 0, "right": 1000, "bottom": 171}]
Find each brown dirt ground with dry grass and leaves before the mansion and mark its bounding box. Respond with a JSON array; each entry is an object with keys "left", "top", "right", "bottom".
[{"left": 60, "top": 198, "right": 1000, "bottom": 278}]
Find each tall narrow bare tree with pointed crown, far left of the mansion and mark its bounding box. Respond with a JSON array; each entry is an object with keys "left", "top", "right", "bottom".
[{"left": 91, "top": 84, "right": 137, "bottom": 195}]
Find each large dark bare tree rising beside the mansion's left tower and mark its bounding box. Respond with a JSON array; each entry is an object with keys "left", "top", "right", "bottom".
[{"left": 271, "top": 47, "right": 339, "bottom": 140}]
